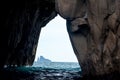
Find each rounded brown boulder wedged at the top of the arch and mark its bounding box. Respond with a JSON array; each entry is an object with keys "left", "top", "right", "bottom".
[{"left": 55, "top": 0, "right": 86, "bottom": 19}]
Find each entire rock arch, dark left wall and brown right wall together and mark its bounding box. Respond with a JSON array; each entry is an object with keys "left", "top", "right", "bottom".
[{"left": 0, "top": 0, "right": 120, "bottom": 79}]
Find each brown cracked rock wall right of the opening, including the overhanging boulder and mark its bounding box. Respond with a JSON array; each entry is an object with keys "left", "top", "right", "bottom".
[{"left": 56, "top": 0, "right": 120, "bottom": 75}]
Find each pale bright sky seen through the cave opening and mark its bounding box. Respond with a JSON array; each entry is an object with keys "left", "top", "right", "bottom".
[{"left": 35, "top": 15, "right": 78, "bottom": 62}]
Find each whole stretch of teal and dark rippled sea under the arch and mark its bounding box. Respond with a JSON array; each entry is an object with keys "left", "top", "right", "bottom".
[{"left": 0, "top": 62, "right": 81, "bottom": 80}]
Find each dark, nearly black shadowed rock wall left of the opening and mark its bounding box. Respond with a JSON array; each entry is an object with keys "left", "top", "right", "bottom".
[{"left": 0, "top": 0, "right": 56, "bottom": 67}]
